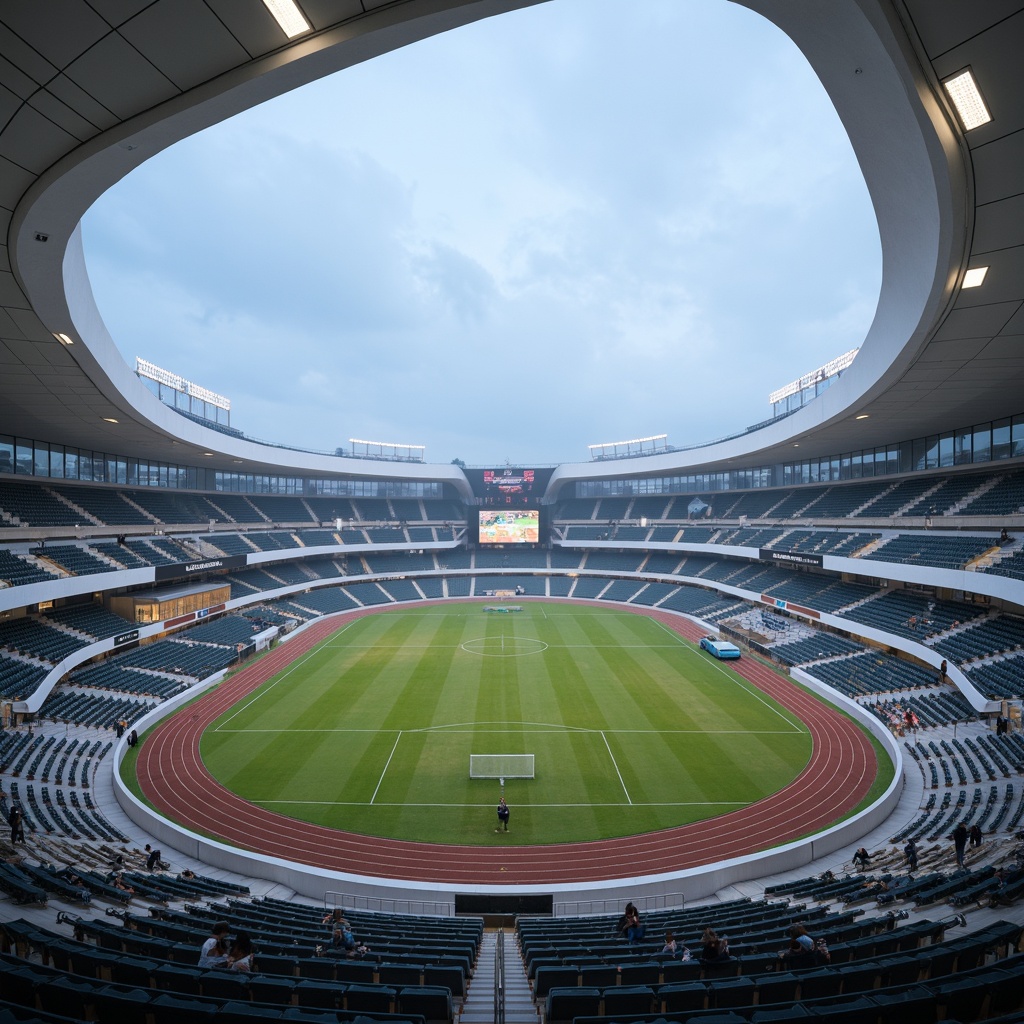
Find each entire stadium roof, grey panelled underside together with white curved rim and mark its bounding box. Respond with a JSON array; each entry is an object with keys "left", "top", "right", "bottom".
[{"left": 0, "top": 0, "right": 1024, "bottom": 483}]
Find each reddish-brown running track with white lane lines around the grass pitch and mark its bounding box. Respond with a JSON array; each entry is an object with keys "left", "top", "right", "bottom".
[{"left": 137, "top": 610, "right": 878, "bottom": 886}]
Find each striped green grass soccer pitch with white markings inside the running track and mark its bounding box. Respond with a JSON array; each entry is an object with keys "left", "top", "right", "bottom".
[{"left": 201, "top": 602, "right": 811, "bottom": 846}]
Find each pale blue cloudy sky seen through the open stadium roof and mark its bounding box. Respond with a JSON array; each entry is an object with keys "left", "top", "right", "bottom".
[{"left": 83, "top": 0, "right": 881, "bottom": 465}]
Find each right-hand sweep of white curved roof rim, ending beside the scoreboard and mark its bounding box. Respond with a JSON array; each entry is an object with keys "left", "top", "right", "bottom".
[{"left": 548, "top": 0, "right": 974, "bottom": 497}]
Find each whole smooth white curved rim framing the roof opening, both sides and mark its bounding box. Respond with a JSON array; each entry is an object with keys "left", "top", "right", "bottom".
[{"left": 11, "top": 0, "right": 972, "bottom": 497}]
